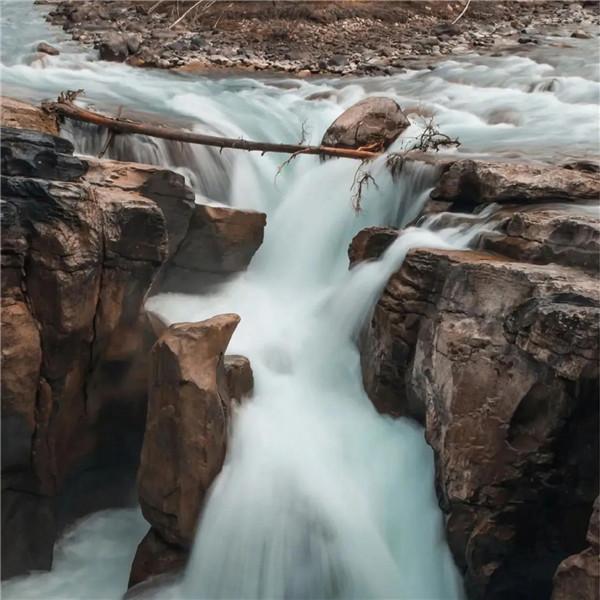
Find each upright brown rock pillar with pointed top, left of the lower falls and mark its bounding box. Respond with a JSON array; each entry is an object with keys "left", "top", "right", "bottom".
[{"left": 138, "top": 314, "right": 239, "bottom": 548}]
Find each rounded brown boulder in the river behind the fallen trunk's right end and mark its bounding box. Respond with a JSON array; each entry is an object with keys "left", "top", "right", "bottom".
[{"left": 321, "top": 96, "right": 410, "bottom": 150}]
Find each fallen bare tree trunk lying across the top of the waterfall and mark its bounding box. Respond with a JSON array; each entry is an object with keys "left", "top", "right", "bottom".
[{"left": 42, "top": 92, "right": 380, "bottom": 160}]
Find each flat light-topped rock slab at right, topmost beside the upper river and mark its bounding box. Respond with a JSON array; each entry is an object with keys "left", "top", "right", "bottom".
[{"left": 431, "top": 160, "right": 600, "bottom": 208}]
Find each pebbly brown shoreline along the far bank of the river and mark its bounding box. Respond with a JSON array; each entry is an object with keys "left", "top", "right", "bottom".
[{"left": 38, "top": 0, "right": 600, "bottom": 76}]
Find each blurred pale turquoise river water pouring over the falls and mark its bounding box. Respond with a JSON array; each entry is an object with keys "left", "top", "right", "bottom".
[{"left": 1, "top": 1, "right": 600, "bottom": 600}]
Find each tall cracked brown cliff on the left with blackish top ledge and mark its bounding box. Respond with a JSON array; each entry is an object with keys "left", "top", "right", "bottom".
[{"left": 2, "top": 129, "right": 172, "bottom": 577}]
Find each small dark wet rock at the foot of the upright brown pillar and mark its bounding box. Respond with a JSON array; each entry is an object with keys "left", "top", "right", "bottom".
[{"left": 129, "top": 529, "right": 188, "bottom": 587}]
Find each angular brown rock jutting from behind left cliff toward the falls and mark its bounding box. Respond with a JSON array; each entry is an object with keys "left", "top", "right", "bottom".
[{"left": 160, "top": 204, "right": 266, "bottom": 292}]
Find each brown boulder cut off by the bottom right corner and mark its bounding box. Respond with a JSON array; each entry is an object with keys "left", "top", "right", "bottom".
[{"left": 552, "top": 498, "right": 600, "bottom": 600}]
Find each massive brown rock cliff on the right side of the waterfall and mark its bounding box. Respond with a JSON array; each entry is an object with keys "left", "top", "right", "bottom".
[{"left": 351, "top": 159, "right": 600, "bottom": 599}]
